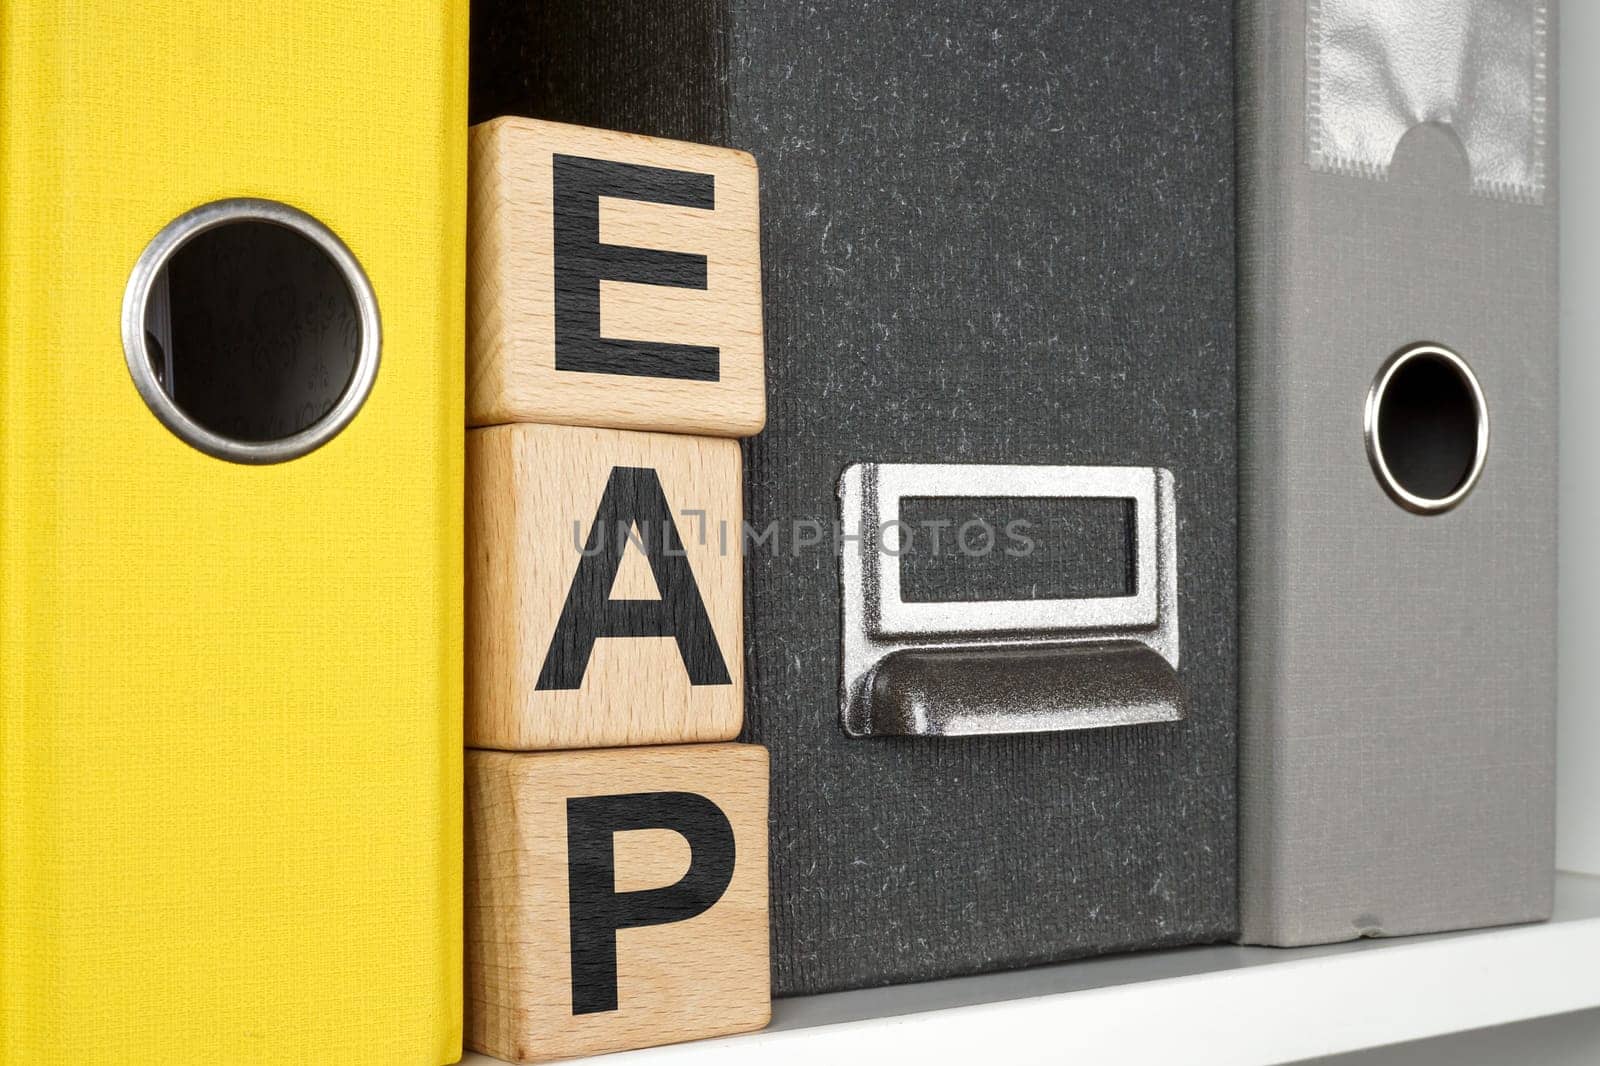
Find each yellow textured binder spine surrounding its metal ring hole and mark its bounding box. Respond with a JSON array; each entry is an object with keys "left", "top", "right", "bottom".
[{"left": 0, "top": 0, "right": 467, "bottom": 1066}]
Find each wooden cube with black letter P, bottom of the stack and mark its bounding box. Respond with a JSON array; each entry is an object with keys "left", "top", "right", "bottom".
[{"left": 466, "top": 744, "right": 771, "bottom": 1063}]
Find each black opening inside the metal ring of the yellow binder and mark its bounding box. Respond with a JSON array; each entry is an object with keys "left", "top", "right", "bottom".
[{"left": 144, "top": 219, "right": 362, "bottom": 443}]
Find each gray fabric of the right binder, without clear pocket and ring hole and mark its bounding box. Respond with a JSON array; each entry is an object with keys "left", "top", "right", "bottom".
[{"left": 1240, "top": 0, "right": 1557, "bottom": 944}]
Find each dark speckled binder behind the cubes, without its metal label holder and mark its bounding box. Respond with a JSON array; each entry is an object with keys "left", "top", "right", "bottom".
[{"left": 474, "top": 0, "right": 1237, "bottom": 994}]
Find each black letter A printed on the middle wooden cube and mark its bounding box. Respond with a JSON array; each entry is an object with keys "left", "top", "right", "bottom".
[{"left": 534, "top": 466, "right": 733, "bottom": 691}]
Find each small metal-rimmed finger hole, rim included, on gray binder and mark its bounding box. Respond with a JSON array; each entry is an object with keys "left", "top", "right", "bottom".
[{"left": 1362, "top": 344, "right": 1490, "bottom": 515}]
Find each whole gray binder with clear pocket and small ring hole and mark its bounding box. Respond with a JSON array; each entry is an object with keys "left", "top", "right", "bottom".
[{"left": 1238, "top": 0, "right": 1557, "bottom": 944}]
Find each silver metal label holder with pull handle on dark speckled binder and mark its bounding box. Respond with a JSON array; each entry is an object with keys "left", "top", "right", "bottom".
[{"left": 840, "top": 463, "right": 1184, "bottom": 736}]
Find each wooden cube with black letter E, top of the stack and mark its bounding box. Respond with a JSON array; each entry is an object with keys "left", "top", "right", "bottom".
[{"left": 467, "top": 118, "right": 766, "bottom": 437}]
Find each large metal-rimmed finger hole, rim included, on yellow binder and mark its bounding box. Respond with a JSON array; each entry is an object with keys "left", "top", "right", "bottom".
[{"left": 123, "top": 200, "right": 379, "bottom": 463}]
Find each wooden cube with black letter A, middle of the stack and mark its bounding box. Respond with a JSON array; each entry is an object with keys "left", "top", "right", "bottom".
[{"left": 466, "top": 426, "right": 744, "bottom": 751}]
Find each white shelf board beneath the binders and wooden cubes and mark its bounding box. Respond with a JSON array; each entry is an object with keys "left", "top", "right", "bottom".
[{"left": 462, "top": 874, "right": 1600, "bottom": 1066}]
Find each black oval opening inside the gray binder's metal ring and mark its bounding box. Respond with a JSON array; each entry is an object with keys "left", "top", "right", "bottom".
[{"left": 1376, "top": 352, "right": 1483, "bottom": 501}]
